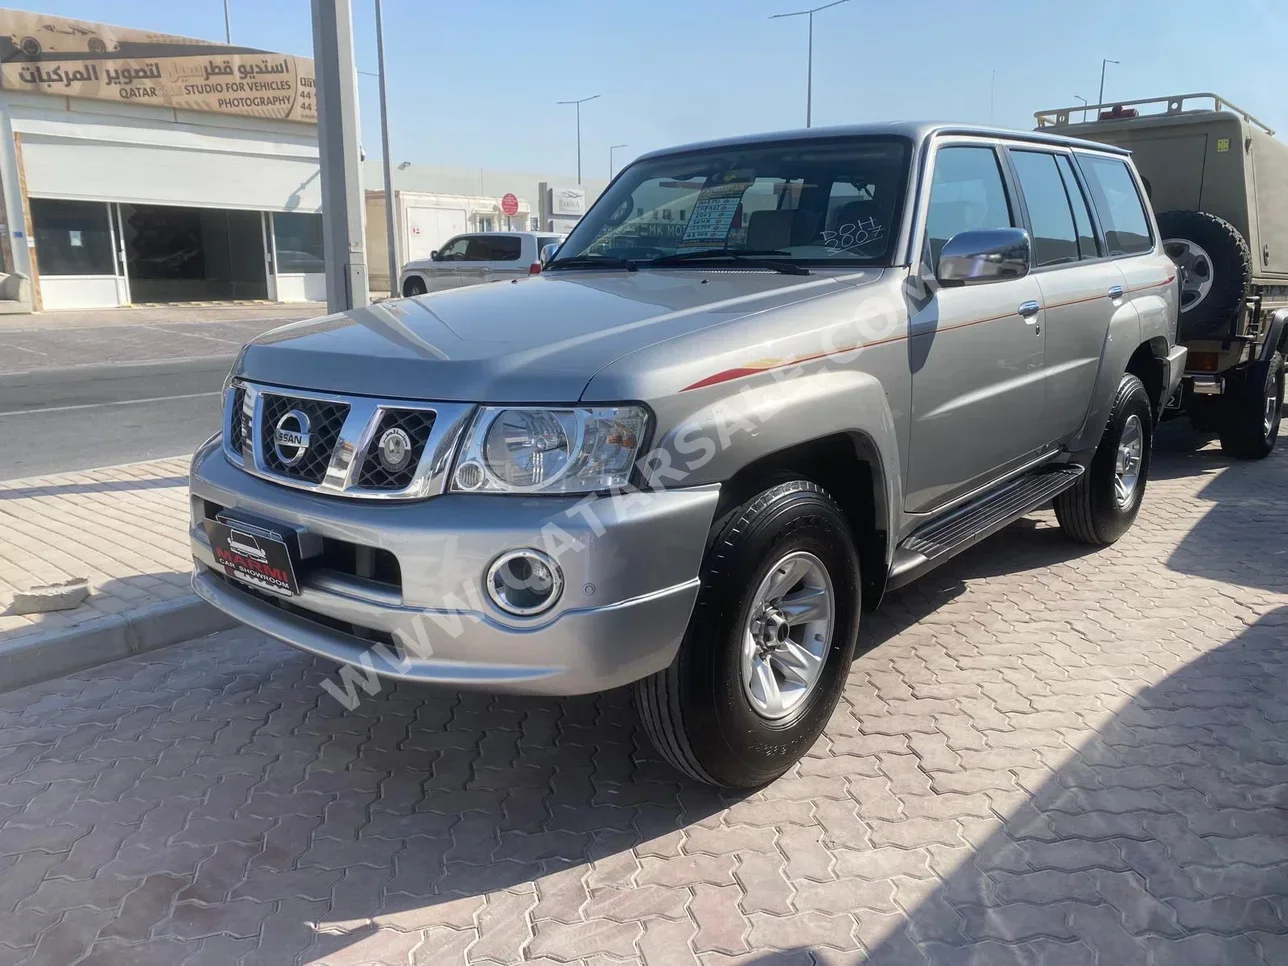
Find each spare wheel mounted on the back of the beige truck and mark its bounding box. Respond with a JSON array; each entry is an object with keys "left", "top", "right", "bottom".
[{"left": 1158, "top": 211, "right": 1252, "bottom": 343}]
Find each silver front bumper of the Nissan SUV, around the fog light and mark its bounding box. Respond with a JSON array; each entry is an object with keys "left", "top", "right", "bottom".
[{"left": 189, "top": 440, "right": 719, "bottom": 694}]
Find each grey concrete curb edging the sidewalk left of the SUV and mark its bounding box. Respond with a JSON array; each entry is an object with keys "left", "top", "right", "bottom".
[{"left": 0, "top": 594, "right": 237, "bottom": 693}]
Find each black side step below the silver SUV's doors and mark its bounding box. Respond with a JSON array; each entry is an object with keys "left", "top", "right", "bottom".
[{"left": 886, "top": 464, "right": 1083, "bottom": 590}]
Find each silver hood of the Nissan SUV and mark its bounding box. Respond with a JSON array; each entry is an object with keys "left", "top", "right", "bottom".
[{"left": 234, "top": 269, "right": 881, "bottom": 403}]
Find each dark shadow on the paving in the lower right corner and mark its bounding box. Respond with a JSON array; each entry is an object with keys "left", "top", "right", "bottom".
[{"left": 850, "top": 607, "right": 1288, "bottom": 966}]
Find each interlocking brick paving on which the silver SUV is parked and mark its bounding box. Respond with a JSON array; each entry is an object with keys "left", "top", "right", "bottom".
[{"left": 0, "top": 428, "right": 1288, "bottom": 966}]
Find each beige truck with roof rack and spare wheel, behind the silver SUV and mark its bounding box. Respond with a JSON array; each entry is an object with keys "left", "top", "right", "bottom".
[{"left": 1034, "top": 93, "right": 1288, "bottom": 459}]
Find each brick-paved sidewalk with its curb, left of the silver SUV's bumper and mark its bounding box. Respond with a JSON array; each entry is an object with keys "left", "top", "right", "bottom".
[{"left": 0, "top": 457, "right": 227, "bottom": 689}]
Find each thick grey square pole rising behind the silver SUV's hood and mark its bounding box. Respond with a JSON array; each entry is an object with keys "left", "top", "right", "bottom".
[{"left": 312, "top": 0, "right": 371, "bottom": 312}]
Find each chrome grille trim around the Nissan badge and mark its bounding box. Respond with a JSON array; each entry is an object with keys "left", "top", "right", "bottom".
[{"left": 224, "top": 380, "right": 477, "bottom": 500}]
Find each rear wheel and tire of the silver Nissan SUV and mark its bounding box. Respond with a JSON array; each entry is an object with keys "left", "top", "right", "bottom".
[{"left": 1054, "top": 372, "right": 1154, "bottom": 546}]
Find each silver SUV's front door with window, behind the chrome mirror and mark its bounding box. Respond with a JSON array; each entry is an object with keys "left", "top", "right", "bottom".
[{"left": 905, "top": 139, "right": 1048, "bottom": 513}]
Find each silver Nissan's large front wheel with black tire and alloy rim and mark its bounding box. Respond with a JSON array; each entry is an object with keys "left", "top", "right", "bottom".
[{"left": 635, "top": 479, "right": 860, "bottom": 788}]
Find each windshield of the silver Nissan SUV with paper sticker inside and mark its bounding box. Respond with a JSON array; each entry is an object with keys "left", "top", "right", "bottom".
[{"left": 550, "top": 138, "right": 909, "bottom": 268}]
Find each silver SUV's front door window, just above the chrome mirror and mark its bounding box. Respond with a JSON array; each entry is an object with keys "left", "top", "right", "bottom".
[{"left": 926, "top": 146, "right": 1015, "bottom": 268}]
